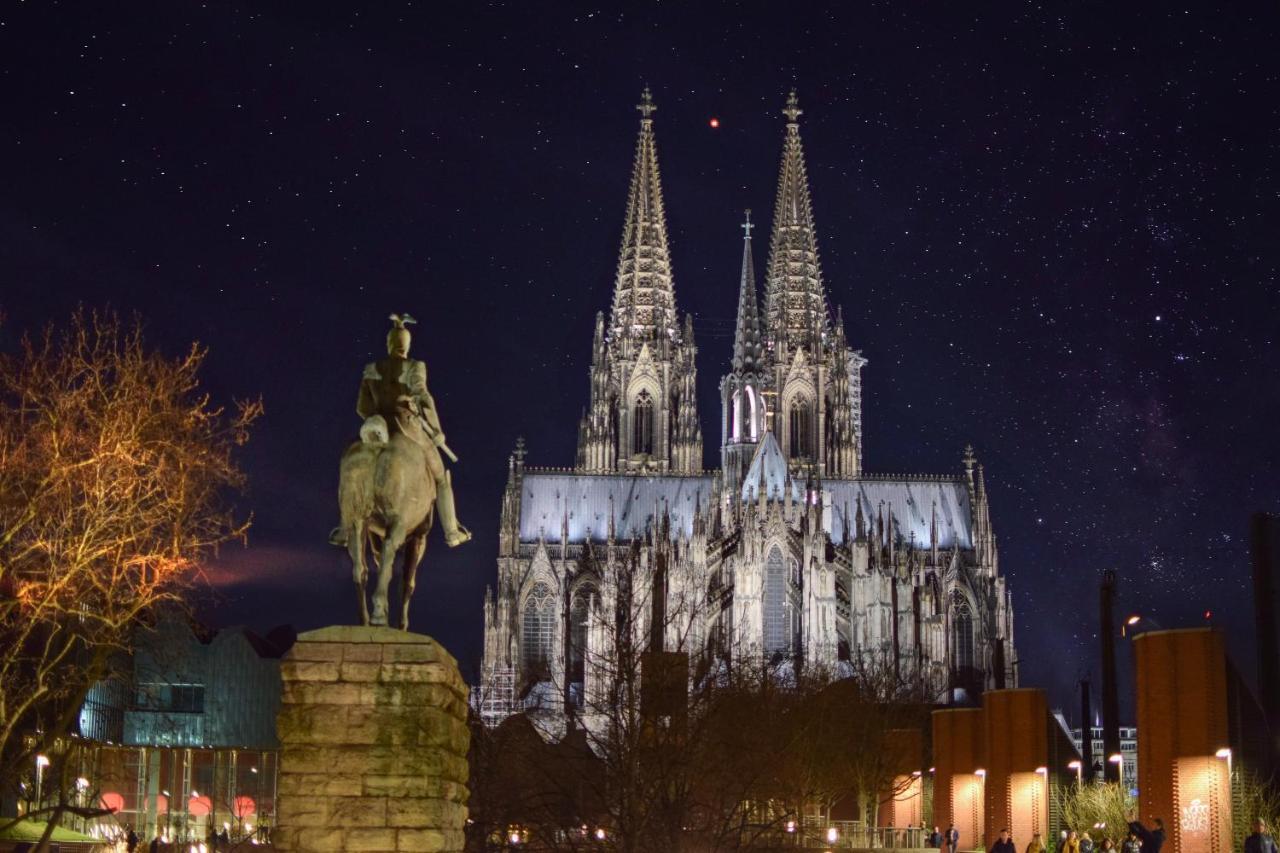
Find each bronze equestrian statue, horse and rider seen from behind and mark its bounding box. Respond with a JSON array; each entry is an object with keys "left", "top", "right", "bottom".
[{"left": 329, "top": 314, "right": 471, "bottom": 630}]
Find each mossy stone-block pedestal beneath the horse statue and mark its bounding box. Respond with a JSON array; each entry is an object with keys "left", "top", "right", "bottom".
[{"left": 273, "top": 626, "right": 470, "bottom": 853}]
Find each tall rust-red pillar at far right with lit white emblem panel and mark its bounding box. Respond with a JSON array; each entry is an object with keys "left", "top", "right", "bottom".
[{"left": 1133, "top": 628, "right": 1231, "bottom": 853}]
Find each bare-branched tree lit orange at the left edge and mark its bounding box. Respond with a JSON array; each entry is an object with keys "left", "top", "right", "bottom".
[{"left": 0, "top": 303, "right": 262, "bottom": 826}]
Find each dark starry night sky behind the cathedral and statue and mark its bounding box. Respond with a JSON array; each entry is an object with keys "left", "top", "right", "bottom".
[{"left": 0, "top": 0, "right": 1280, "bottom": 703}]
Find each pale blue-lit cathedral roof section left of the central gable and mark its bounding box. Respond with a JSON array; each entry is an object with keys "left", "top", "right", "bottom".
[{"left": 520, "top": 471, "right": 714, "bottom": 542}]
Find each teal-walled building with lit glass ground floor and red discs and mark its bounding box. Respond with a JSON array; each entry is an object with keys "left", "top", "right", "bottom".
[{"left": 72, "top": 620, "right": 293, "bottom": 841}]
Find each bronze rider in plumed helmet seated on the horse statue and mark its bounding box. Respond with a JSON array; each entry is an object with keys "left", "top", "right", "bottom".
[{"left": 329, "top": 314, "right": 471, "bottom": 548}]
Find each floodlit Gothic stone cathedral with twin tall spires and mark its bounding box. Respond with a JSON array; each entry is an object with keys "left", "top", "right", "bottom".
[{"left": 476, "top": 91, "right": 1018, "bottom": 730}]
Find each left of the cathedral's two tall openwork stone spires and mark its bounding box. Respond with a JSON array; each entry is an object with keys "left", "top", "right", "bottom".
[{"left": 609, "top": 86, "right": 677, "bottom": 343}]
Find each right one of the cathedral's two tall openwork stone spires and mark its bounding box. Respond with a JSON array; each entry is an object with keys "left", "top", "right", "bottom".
[{"left": 765, "top": 90, "right": 831, "bottom": 357}]
